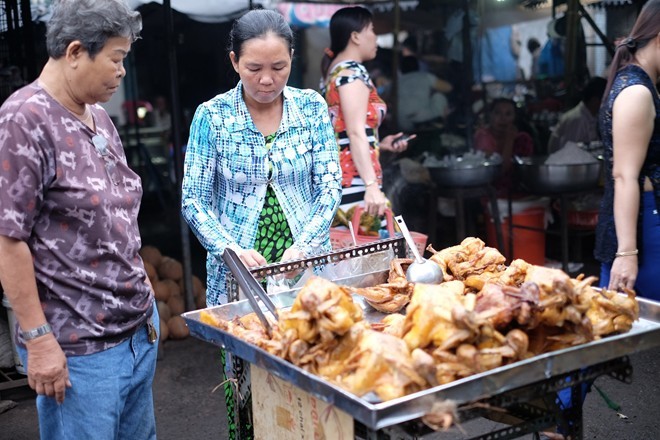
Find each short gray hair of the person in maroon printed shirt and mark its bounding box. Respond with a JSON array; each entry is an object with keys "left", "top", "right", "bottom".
[{"left": 46, "top": 0, "right": 142, "bottom": 59}]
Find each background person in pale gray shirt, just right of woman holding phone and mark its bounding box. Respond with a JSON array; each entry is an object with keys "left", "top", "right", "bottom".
[{"left": 398, "top": 56, "right": 452, "bottom": 132}]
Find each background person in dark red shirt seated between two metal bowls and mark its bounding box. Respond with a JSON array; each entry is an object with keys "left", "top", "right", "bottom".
[{"left": 474, "top": 98, "right": 534, "bottom": 197}]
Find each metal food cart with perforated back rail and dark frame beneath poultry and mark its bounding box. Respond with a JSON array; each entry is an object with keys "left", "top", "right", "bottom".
[{"left": 183, "top": 239, "right": 660, "bottom": 439}]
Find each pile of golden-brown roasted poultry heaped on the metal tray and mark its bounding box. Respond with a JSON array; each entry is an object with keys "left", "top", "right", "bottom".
[{"left": 201, "top": 237, "right": 639, "bottom": 400}]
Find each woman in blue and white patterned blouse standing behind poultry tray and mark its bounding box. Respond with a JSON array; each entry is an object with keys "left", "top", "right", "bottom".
[{"left": 182, "top": 10, "right": 341, "bottom": 306}]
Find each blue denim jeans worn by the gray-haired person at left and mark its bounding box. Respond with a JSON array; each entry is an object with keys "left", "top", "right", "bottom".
[{"left": 19, "top": 307, "right": 160, "bottom": 440}]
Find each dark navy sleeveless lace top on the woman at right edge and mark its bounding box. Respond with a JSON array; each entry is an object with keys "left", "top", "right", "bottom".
[{"left": 594, "top": 64, "right": 660, "bottom": 263}]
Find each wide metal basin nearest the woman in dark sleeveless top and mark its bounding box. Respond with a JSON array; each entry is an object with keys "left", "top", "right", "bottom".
[{"left": 514, "top": 157, "right": 603, "bottom": 194}]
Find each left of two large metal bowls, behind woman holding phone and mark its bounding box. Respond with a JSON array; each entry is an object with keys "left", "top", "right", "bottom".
[{"left": 428, "top": 161, "right": 502, "bottom": 188}]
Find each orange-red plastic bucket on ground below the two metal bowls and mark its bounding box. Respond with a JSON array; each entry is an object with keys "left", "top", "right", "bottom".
[{"left": 486, "top": 207, "right": 545, "bottom": 266}]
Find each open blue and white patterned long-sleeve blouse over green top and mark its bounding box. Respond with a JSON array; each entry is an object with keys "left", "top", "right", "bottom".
[{"left": 182, "top": 82, "right": 341, "bottom": 306}]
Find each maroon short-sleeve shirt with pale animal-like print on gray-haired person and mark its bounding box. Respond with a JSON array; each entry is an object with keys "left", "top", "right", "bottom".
[{"left": 0, "top": 81, "right": 153, "bottom": 355}]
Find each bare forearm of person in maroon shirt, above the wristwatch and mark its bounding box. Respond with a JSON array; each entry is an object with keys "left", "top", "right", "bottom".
[{"left": 0, "top": 236, "right": 46, "bottom": 330}]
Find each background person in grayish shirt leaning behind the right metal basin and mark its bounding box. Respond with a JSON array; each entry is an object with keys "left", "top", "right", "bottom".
[{"left": 548, "top": 76, "right": 607, "bottom": 153}]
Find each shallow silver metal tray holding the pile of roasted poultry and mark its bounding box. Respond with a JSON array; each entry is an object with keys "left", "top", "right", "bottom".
[{"left": 182, "top": 282, "right": 660, "bottom": 430}]
